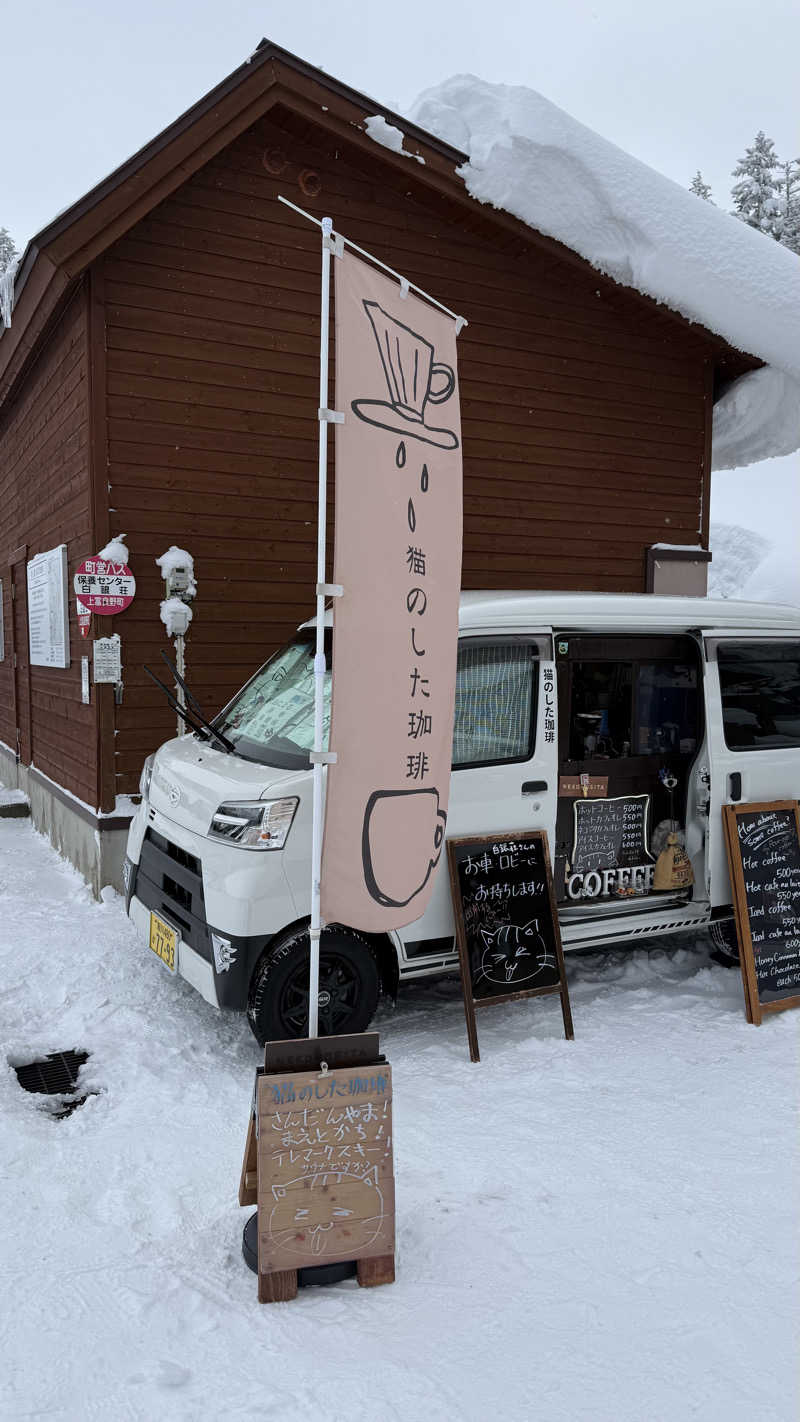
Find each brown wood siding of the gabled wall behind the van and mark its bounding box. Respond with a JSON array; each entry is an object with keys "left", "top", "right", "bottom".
[{"left": 102, "top": 114, "right": 710, "bottom": 791}]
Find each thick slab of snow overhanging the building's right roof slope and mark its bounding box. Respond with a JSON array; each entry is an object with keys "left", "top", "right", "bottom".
[{"left": 411, "top": 74, "right": 800, "bottom": 468}]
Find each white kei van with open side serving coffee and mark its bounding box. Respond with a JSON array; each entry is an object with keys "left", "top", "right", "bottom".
[{"left": 125, "top": 593, "right": 800, "bottom": 1041}]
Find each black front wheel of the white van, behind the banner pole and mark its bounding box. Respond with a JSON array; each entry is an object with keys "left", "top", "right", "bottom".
[{"left": 247, "top": 929, "right": 381, "bottom": 1047}]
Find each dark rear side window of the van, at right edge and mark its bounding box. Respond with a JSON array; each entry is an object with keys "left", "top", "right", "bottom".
[{"left": 716, "top": 641, "right": 800, "bottom": 751}]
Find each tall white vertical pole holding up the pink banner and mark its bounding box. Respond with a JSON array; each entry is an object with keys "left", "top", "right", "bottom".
[{"left": 308, "top": 218, "right": 334, "bottom": 1037}]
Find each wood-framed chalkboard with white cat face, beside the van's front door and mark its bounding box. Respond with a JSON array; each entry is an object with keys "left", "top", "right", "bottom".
[{"left": 448, "top": 829, "right": 573, "bottom": 1062}]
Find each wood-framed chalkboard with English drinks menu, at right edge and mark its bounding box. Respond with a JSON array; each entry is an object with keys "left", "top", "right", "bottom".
[{"left": 722, "top": 801, "right": 800, "bottom": 1027}]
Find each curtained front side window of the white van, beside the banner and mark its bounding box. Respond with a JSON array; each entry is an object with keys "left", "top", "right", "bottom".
[{"left": 453, "top": 641, "right": 539, "bottom": 768}]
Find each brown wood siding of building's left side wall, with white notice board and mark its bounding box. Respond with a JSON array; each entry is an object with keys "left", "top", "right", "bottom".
[{"left": 0, "top": 282, "right": 97, "bottom": 806}]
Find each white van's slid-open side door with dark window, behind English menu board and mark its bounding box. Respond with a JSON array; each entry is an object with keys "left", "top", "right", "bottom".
[{"left": 703, "top": 629, "right": 800, "bottom": 907}]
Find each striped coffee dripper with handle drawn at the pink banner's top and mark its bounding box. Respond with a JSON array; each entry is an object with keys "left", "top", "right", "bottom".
[{"left": 352, "top": 301, "right": 459, "bottom": 449}]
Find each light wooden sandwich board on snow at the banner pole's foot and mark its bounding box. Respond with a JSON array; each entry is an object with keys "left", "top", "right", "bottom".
[{"left": 239, "top": 1032, "right": 395, "bottom": 1304}]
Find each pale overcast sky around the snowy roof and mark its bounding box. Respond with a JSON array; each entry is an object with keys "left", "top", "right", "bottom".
[{"left": 0, "top": 0, "right": 800, "bottom": 577}]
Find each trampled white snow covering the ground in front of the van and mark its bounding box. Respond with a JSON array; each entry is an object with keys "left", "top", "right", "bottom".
[{"left": 0, "top": 820, "right": 800, "bottom": 1422}]
